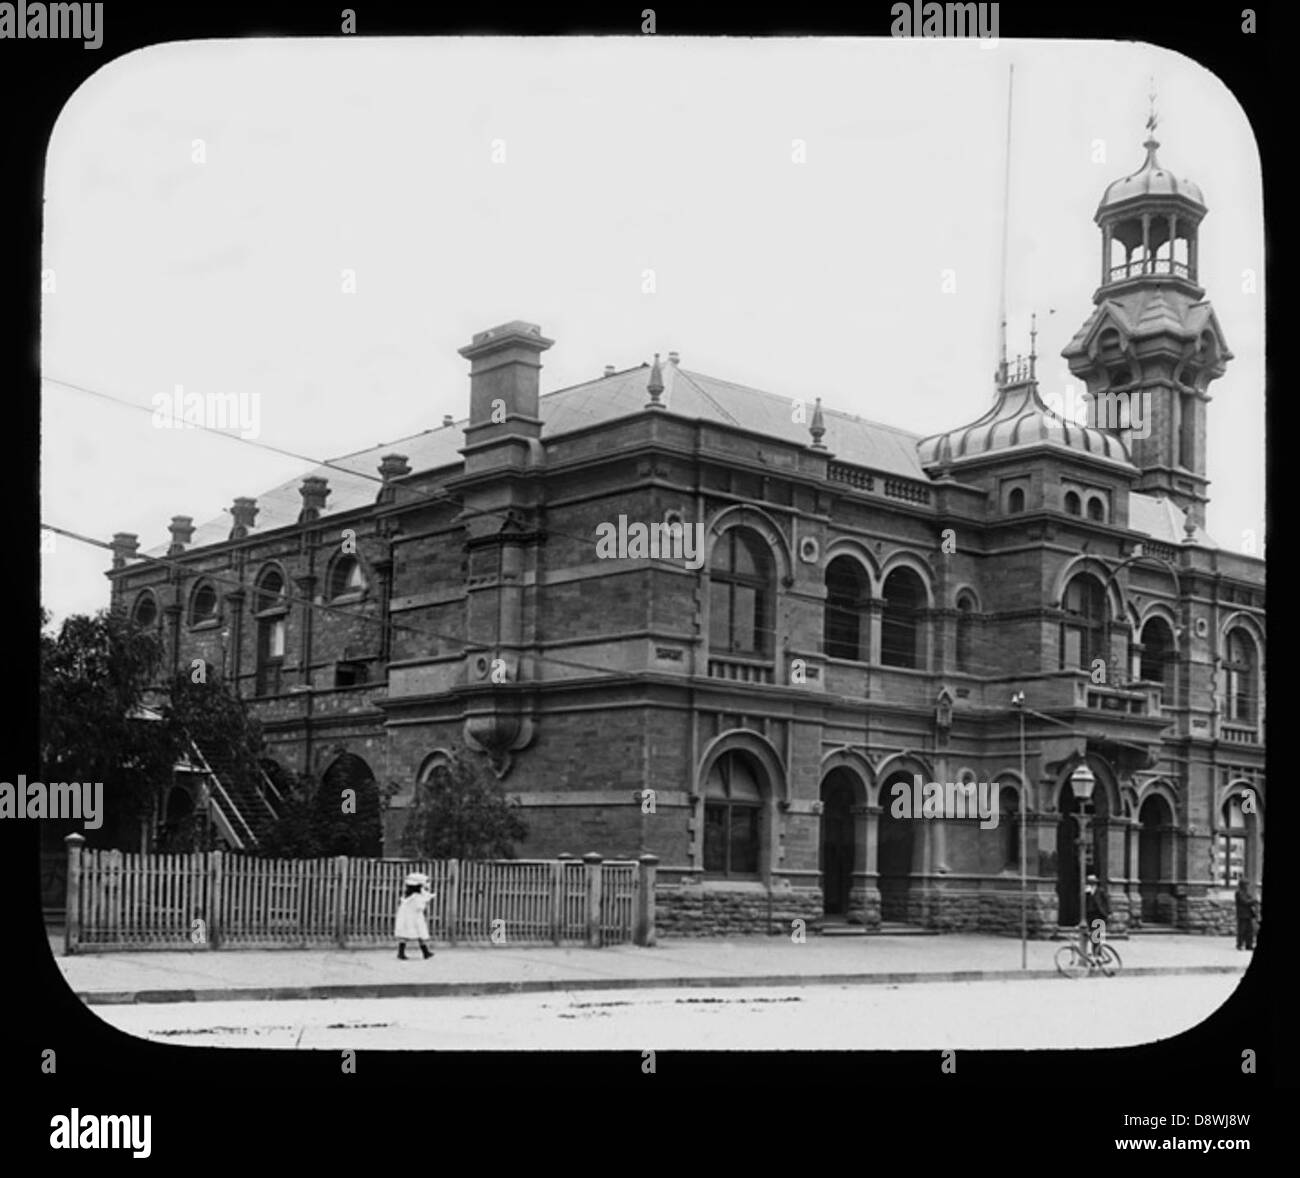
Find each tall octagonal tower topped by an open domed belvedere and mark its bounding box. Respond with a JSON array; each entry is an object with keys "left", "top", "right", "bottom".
[{"left": 1061, "top": 114, "right": 1232, "bottom": 528}]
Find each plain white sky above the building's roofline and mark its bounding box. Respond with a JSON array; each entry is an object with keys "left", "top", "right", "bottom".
[{"left": 42, "top": 36, "right": 1264, "bottom": 619}]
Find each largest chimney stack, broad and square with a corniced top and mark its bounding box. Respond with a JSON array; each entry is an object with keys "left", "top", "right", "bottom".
[{"left": 460, "top": 320, "right": 555, "bottom": 443}]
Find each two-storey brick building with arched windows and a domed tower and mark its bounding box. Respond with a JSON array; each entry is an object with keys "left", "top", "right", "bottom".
[{"left": 109, "top": 130, "right": 1265, "bottom": 934}]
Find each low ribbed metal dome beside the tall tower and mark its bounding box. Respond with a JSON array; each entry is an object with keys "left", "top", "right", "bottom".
[{"left": 917, "top": 381, "right": 1128, "bottom": 469}]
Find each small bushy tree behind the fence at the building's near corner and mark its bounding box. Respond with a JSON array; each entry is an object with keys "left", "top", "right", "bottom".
[{"left": 402, "top": 755, "right": 528, "bottom": 859}]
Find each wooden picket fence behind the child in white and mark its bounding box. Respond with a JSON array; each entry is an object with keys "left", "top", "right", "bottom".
[{"left": 65, "top": 835, "right": 658, "bottom": 953}]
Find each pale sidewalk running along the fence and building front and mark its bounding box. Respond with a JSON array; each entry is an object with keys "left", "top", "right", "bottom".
[{"left": 52, "top": 935, "right": 1251, "bottom": 1005}]
